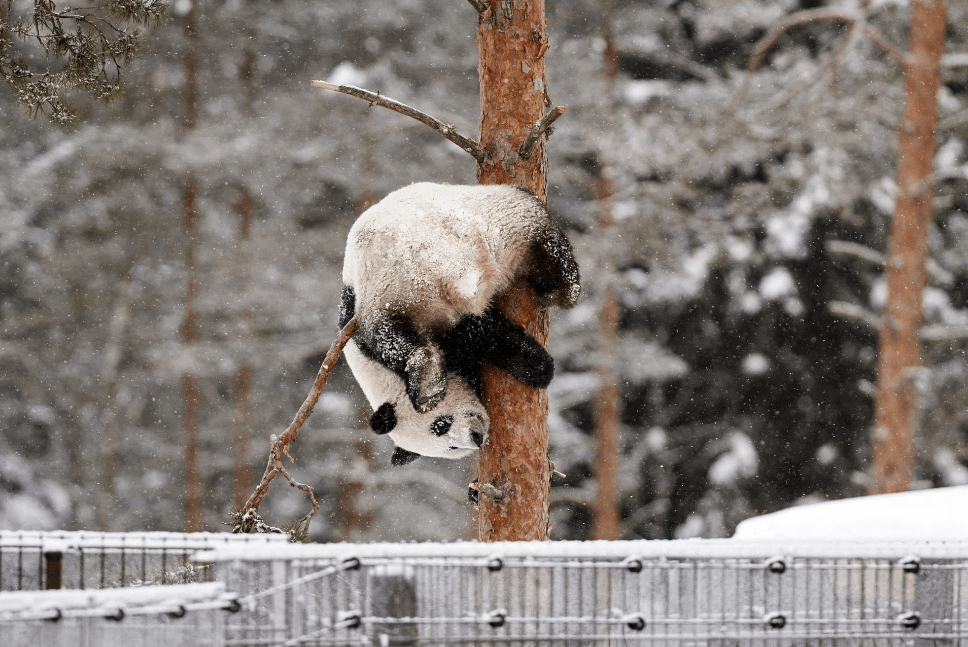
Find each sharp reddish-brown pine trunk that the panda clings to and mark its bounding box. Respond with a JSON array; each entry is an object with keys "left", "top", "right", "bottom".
[{"left": 477, "top": 0, "right": 551, "bottom": 541}]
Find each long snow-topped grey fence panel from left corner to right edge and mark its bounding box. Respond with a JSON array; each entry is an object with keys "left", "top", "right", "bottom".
[{"left": 207, "top": 540, "right": 968, "bottom": 647}]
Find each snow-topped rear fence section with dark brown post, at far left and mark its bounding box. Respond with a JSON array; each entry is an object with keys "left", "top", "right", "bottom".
[{"left": 0, "top": 530, "right": 288, "bottom": 591}]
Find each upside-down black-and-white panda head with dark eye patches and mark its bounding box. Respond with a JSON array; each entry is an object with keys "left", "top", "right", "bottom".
[{"left": 370, "top": 375, "right": 490, "bottom": 465}]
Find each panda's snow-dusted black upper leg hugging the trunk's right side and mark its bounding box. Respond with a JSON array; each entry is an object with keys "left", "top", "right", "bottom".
[{"left": 526, "top": 223, "right": 580, "bottom": 310}]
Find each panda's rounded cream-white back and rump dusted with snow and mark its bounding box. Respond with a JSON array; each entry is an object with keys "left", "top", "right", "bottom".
[{"left": 343, "top": 183, "right": 548, "bottom": 328}]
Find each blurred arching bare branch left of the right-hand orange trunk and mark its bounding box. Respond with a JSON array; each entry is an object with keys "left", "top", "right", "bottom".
[{"left": 733, "top": 7, "right": 907, "bottom": 111}]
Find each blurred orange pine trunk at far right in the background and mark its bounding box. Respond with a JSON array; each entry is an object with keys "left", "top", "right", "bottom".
[{"left": 870, "top": 0, "right": 947, "bottom": 494}]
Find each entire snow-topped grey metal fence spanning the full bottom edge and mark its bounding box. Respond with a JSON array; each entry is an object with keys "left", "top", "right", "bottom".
[{"left": 0, "top": 533, "right": 968, "bottom": 647}]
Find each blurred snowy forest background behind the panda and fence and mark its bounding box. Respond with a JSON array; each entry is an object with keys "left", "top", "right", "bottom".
[{"left": 0, "top": 0, "right": 968, "bottom": 541}]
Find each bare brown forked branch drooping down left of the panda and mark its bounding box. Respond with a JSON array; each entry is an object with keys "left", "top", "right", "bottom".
[{"left": 232, "top": 317, "right": 356, "bottom": 534}]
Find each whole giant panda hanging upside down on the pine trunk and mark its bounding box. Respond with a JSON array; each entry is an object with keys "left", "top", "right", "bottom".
[{"left": 339, "top": 183, "right": 579, "bottom": 465}]
